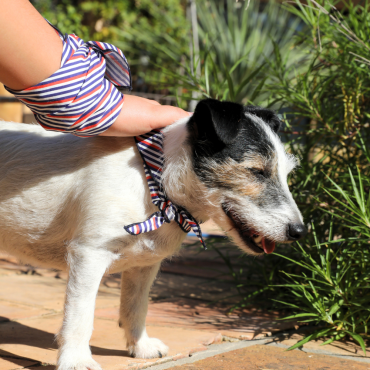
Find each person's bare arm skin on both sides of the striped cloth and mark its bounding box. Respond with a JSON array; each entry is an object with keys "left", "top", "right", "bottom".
[{"left": 0, "top": 0, "right": 188, "bottom": 136}]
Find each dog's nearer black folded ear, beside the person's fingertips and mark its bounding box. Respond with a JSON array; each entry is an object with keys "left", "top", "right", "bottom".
[{"left": 191, "top": 99, "right": 244, "bottom": 145}]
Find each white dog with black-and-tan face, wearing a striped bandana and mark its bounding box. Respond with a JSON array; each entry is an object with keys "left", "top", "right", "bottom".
[{"left": 0, "top": 99, "right": 306, "bottom": 370}]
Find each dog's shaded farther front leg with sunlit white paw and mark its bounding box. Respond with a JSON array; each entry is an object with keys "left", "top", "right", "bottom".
[{"left": 119, "top": 263, "right": 168, "bottom": 358}]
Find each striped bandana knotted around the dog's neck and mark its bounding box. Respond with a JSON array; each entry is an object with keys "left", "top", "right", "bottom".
[{"left": 124, "top": 130, "right": 205, "bottom": 247}]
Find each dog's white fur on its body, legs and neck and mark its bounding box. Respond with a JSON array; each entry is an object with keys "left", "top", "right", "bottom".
[{"left": 0, "top": 119, "right": 300, "bottom": 370}]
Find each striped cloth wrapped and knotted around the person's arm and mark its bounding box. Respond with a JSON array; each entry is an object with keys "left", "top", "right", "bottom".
[{"left": 6, "top": 20, "right": 131, "bottom": 137}]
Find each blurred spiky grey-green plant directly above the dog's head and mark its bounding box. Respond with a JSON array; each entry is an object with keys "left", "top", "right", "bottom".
[{"left": 157, "top": 0, "right": 305, "bottom": 104}]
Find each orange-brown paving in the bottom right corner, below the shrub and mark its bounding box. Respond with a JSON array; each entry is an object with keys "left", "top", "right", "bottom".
[{"left": 165, "top": 345, "right": 370, "bottom": 370}]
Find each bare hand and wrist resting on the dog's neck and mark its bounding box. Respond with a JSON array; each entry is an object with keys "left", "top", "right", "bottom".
[{"left": 101, "top": 95, "right": 190, "bottom": 136}]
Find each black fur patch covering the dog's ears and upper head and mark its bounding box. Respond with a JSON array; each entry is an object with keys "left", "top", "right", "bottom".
[{"left": 188, "top": 99, "right": 280, "bottom": 185}]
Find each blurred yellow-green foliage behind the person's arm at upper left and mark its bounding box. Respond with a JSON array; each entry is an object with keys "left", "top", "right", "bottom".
[{"left": 31, "top": 0, "right": 189, "bottom": 92}]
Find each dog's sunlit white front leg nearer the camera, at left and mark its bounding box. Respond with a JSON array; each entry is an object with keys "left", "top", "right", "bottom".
[{"left": 57, "top": 248, "right": 114, "bottom": 370}]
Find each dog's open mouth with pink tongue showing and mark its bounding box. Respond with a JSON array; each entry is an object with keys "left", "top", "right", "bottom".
[{"left": 222, "top": 203, "right": 275, "bottom": 254}]
